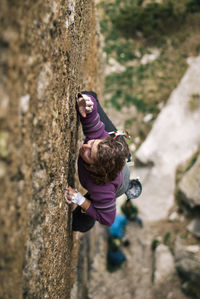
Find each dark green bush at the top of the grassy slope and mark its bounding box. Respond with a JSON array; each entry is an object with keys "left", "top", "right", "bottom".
[{"left": 111, "top": 0, "right": 186, "bottom": 42}]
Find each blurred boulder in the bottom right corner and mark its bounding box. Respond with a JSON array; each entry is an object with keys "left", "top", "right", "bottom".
[{"left": 174, "top": 238, "right": 200, "bottom": 298}]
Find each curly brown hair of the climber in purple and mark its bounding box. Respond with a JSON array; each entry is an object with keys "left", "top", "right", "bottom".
[{"left": 85, "top": 137, "right": 129, "bottom": 185}]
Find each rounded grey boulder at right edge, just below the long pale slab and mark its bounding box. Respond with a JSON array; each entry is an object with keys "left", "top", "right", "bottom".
[{"left": 177, "top": 155, "right": 200, "bottom": 208}]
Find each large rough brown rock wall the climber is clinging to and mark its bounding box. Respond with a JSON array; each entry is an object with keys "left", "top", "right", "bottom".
[{"left": 0, "top": 0, "right": 103, "bottom": 298}]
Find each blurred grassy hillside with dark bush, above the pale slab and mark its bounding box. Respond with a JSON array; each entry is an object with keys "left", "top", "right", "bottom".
[{"left": 99, "top": 0, "right": 200, "bottom": 140}]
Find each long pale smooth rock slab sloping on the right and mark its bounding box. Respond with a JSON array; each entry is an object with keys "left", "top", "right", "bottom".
[{"left": 133, "top": 57, "right": 200, "bottom": 221}]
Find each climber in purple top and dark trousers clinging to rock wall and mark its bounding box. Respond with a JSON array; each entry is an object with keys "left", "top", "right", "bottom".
[{"left": 65, "top": 91, "right": 135, "bottom": 232}]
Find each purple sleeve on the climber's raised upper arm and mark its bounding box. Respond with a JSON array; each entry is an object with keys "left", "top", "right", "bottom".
[{"left": 76, "top": 95, "right": 109, "bottom": 139}]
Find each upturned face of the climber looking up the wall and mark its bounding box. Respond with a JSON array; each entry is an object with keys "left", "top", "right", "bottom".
[{"left": 79, "top": 139, "right": 102, "bottom": 164}]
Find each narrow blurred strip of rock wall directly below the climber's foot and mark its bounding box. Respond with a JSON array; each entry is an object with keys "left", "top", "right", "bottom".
[{"left": 71, "top": 222, "right": 110, "bottom": 299}]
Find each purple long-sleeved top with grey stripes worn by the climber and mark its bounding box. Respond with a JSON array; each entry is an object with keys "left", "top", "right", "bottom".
[{"left": 77, "top": 95, "right": 122, "bottom": 226}]
